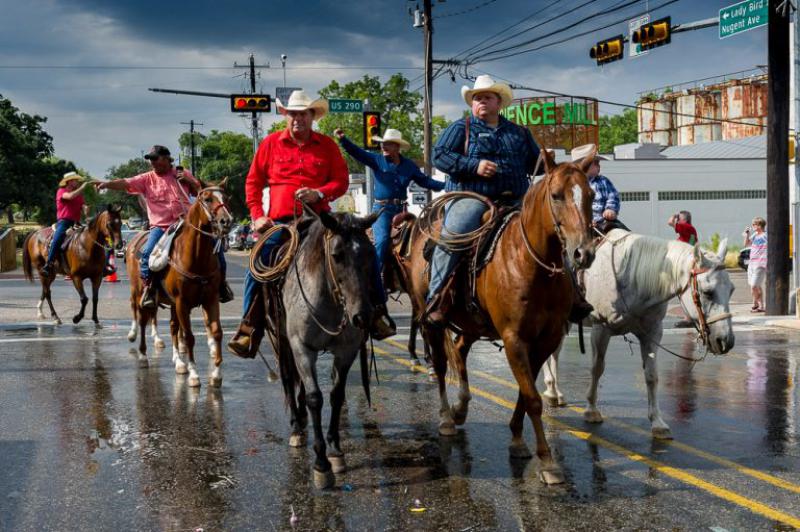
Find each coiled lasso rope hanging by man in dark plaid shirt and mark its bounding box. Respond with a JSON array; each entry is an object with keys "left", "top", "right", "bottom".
[{"left": 417, "top": 191, "right": 497, "bottom": 252}]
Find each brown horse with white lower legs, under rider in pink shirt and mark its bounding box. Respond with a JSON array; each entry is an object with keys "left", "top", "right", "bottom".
[{"left": 126, "top": 179, "right": 233, "bottom": 387}]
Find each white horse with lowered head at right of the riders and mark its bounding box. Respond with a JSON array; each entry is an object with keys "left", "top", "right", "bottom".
[{"left": 543, "top": 229, "right": 734, "bottom": 439}]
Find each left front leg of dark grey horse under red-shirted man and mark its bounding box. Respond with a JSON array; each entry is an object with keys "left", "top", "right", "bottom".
[{"left": 291, "top": 339, "right": 335, "bottom": 489}]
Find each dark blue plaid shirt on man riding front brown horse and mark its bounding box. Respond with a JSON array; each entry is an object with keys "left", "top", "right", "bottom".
[{"left": 433, "top": 116, "right": 539, "bottom": 199}]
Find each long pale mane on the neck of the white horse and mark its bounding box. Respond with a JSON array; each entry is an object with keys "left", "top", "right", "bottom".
[{"left": 610, "top": 231, "right": 694, "bottom": 298}]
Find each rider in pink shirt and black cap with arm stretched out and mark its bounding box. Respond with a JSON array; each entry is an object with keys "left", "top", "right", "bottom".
[{"left": 97, "top": 145, "right": 233, "bottom": 308}]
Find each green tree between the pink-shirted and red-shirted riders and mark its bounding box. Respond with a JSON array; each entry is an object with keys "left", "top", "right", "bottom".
[{"left": 180, "top": 129, "right": 253, "bottom": 218}]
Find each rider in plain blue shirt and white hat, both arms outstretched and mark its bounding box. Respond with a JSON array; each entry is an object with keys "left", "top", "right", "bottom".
[{"left": 334, "top": 129, "right": 444, "bottom": 334}]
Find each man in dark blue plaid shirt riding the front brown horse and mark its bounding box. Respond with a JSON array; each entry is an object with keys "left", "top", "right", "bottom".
[{"left": 426, "top": 76, "right": 539, "bottom": 325}]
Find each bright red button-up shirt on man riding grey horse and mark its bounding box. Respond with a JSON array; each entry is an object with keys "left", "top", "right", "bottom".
[{"left": 245, "top": 130, "right": 349, "bottom": 221}]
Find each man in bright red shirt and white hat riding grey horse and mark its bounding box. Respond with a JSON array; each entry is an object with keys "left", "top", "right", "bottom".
[{"left": 228, "top": 91, "right": 394, "bottom": 358}]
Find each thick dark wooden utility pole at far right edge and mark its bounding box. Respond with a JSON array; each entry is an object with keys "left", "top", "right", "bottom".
[{"left": 766, "top": 0, "right": 789, "bottom": 315}]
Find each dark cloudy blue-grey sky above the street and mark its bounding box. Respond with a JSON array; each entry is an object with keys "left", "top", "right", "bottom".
[{"left": 0, "top": 0, "right": 766, "bottom": 176}]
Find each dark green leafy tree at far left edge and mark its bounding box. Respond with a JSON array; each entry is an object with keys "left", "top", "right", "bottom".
[{"left": 0, "top": 95, "right": 57, "bottom": 223}]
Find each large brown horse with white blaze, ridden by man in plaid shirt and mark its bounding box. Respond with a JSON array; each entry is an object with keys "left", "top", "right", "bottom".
[{"left": 407, "top": 151, "right": 594, "bottom": 484}]
